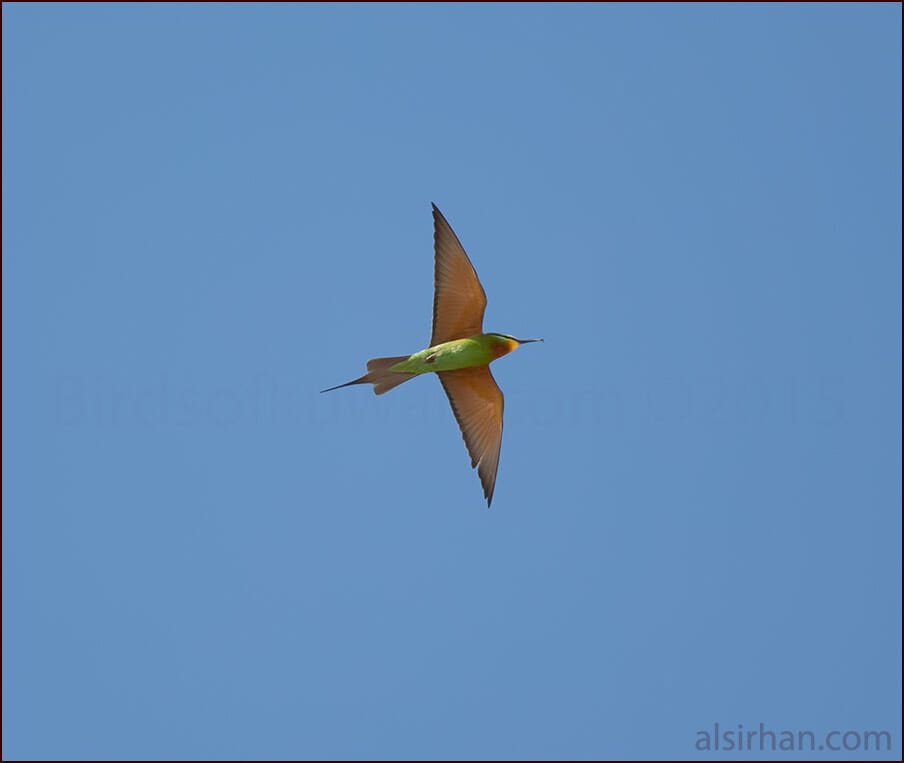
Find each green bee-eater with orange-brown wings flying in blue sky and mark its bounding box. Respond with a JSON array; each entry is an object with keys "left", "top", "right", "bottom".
[{"left": 321, "top": 204, "right": 543, "bottom": 507}]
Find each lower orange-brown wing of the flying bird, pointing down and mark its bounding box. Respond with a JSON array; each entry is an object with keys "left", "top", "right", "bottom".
[{"left": 437, "top": 366, "right": 504, "bottom": 506}]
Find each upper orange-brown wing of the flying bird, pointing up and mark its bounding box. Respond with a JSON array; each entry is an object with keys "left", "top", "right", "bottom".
[{"left": 430, "top": 204, "right": 487, "bottom": 347}]
